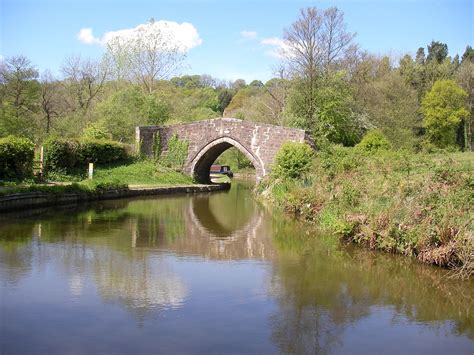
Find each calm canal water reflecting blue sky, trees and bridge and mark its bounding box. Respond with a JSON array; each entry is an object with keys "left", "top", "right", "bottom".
[{"left": 0, "top": 183, "right": 474, "bottom": 355}]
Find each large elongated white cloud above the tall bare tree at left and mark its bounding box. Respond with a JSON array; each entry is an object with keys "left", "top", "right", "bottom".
[{"left": 77, "top": 21, "right": 202, "bottom": 52}]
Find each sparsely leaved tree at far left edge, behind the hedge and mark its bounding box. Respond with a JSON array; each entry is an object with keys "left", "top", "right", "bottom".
[{"left": 0, "top": 56, "right": 39, "bottom": 138}]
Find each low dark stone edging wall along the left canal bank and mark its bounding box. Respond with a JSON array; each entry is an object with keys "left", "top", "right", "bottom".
[{"left": 0, "top": 184, "right": 230, "bottom": 213}]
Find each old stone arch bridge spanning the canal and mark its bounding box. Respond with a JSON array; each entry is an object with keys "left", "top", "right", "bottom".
[{"left": 136, "top": 118, "right": 313, "bottom": 183}]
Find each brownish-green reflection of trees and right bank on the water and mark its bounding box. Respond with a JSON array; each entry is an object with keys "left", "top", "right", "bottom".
[{"left": 271, "top": 220, "right": 474, "bottom": 354}]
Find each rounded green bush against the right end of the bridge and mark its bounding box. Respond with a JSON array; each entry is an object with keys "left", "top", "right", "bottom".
[{"left": 273, "top": 143, "right": 313, "bottom": 179}]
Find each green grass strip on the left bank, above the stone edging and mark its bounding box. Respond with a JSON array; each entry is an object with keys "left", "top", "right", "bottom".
[{"left": 0, "top": 161, "right": 193, "bottom": 195}]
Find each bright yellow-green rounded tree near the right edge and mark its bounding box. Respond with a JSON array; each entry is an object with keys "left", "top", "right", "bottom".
[{"left": 421, "top": 80, "right": 469, "bottom": 148}]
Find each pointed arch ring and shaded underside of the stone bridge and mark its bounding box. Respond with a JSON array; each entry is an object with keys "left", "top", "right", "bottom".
[{"left": 190, "top": 137, "right": 265, "bottom": 184}]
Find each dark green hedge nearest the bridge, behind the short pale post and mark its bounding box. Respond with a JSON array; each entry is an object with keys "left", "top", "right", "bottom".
[{"left": 44, "top": 138, "right": 130, "bottom": 173}]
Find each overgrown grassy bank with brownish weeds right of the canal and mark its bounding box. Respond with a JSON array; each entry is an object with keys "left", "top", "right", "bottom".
[{"left": 258, "top": 146, "right": 474, "bottom": 277}]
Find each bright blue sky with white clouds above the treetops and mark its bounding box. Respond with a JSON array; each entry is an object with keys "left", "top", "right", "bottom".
[{"left": 0, "top": 0, "right": 474, "bottom": 82}]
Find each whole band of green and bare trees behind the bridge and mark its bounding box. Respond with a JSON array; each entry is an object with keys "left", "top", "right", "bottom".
[{"left": 0, "top": 11, "right": 474, "bottom": 150}]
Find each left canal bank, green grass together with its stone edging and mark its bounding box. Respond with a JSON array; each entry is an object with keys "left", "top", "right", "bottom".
[{"left": 0, "top": 160, "right": 230, "bottom": 212}]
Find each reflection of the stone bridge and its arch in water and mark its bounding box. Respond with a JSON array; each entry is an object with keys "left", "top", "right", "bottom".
[{"left": 132, "top": 184, "right": 273, "bottom": 260}]
